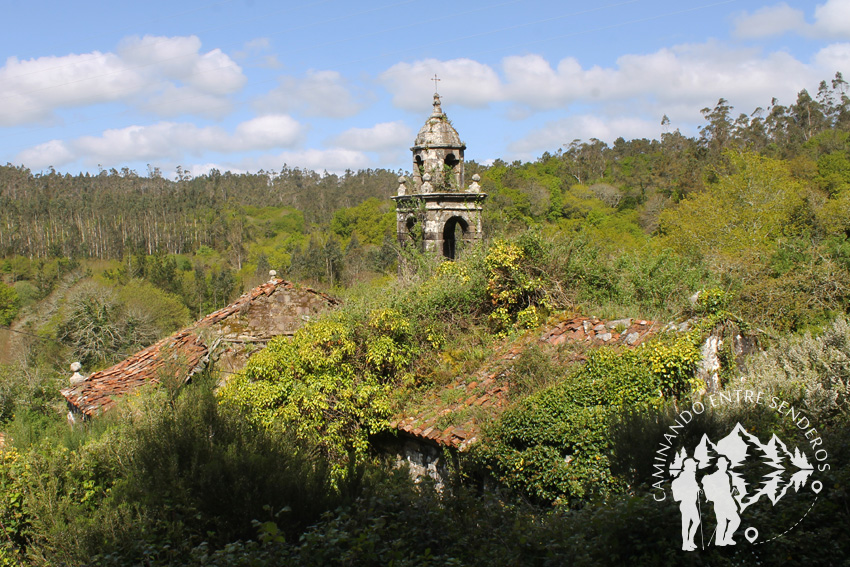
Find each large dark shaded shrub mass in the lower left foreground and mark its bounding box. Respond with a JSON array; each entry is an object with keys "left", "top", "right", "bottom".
[{"left": 0, "top": 374, "right": 348, "bottom": 565}]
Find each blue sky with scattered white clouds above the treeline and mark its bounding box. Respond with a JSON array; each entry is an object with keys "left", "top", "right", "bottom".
[{"left": 0, "top": 0, "right": 850, "bottom": 175}]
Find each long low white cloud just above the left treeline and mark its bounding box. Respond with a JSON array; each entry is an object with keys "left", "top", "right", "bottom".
[{"left": 16, "top": 115, "right": 303, "bottom": 169}]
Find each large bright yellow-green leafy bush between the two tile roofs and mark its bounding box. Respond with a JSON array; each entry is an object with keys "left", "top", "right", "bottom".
[{"left": 220, "top": 309, "right": 416, "bottom": 478}]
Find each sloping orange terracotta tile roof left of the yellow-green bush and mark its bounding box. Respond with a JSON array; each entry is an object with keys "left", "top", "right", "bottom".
[{"left": 61, "top": 279, "right": 339, "bottom": 416}]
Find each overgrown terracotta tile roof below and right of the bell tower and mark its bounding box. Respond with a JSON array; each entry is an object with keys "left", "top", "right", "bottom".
[{"left": 391, "top": 317, "right": 660, "bottom": 451}]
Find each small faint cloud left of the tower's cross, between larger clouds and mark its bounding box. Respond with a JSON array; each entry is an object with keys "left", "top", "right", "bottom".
[{"left": 254, "top": 71, "right": 362, "bottom": 118}]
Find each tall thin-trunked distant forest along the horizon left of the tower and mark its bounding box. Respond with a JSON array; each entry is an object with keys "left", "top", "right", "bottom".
[{"left": 0, "top": 165, "right": 398, "bottom": 259}]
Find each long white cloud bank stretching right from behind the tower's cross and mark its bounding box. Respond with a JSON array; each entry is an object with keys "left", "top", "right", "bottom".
[{"left": 381, "top": 41, "right": 816, "bottom": 122}]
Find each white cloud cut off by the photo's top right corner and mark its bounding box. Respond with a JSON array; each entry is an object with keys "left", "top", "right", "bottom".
[{"left": 733, "top": 0, "right": 850, "bottom": 39}]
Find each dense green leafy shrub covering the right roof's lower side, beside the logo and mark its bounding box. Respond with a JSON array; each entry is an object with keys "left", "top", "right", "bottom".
[{"left": 476, "top": 334, "right": 700, "bottom": 506}]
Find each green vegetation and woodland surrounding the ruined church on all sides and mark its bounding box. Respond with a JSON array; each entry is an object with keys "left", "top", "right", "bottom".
[{"left": 0, "top": 75, "right": 850, "bottom": 566}]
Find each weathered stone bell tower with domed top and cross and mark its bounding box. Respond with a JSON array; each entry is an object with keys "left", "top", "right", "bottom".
[{"left": 393, "top": 93, "right": 487, "bottom": 259}]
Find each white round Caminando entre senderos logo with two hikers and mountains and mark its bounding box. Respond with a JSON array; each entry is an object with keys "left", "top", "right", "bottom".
[{"left": 652, "top": 390, "right": 829, "bottom": 551}]
